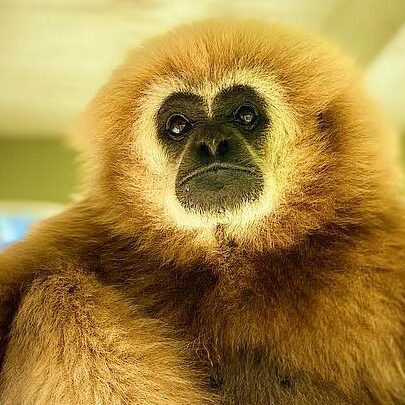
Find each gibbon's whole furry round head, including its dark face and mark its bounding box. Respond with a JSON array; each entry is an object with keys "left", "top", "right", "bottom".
[{"left": 81, "top": 21, "right": 389, "bottom": 257}]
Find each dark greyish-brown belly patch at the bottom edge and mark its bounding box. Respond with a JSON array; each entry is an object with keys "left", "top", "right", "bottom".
[{"left": 205, "top": 349, "right": 354, "bottom": 405}]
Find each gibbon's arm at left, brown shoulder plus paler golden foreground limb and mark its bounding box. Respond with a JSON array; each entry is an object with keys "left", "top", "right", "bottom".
[{"left": 0, "top": 204, "right": 210, "bottom": 405}]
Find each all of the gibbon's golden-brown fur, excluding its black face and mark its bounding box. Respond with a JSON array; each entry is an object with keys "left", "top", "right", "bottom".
[{"left": 0, "top": 21, "right": 405, "bottom": 405}]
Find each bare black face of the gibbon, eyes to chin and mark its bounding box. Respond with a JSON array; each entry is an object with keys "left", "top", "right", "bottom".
[{"left": 157, "top": 85, "right": 269, "bottom": 213}]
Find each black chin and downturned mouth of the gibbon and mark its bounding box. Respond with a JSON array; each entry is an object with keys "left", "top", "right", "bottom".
[{"left": 176, "top": 163, "right": 263, "bottom": 213}]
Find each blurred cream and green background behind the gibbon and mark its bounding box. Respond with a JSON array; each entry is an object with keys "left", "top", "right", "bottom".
[{"left": 0, "top": 0, "right": 405, "bottom": 243}]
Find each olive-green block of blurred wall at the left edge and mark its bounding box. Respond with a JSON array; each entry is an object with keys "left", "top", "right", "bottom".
[{"left": 0, "top": 138, "right": 77, "bottom": 202}]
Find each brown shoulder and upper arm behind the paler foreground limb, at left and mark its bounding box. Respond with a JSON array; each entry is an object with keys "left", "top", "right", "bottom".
[{"left": 0, "top": 201, "right": 105, "bottom": 356}]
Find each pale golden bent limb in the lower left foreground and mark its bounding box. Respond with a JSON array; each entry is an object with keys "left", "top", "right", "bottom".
[{"left": 0, "top": 266, "right": 212, "bottom": 405}]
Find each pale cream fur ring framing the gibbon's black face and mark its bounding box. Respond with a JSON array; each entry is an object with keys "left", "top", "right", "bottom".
[{"left": 134, "top": 69, "right": 297, "bottom": 241}]
